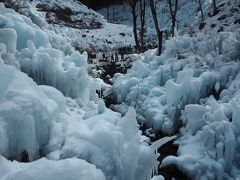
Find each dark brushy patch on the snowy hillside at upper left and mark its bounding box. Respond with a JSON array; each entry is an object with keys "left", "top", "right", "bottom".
[{"left": 34, "top": 0, "right": 104, "bottom": 29}]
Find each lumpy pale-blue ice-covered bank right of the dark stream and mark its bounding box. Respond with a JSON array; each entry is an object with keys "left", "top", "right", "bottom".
[{"left": 112, "top": 28, "right": 240, "bottom": 179}]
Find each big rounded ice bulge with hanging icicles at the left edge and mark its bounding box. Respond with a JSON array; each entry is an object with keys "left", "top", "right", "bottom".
[{"left": 0, "top": 64, "right": 59, "bottom": 161}]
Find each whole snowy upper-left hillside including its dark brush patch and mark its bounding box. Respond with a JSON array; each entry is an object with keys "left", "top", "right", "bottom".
[{"left": 3, "top": 0, "right": 134, "bottom": 53}]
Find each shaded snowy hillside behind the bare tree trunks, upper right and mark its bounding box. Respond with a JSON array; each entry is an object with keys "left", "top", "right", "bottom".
[{"left": 98, "top": 0, "right": 240, "bottom": 45}]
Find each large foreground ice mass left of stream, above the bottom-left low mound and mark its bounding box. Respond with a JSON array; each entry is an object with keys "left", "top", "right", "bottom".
[{"left": 0, "top": 64, "right": 159, "bottom": 179}]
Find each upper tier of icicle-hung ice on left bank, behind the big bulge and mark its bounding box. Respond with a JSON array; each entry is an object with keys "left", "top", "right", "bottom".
[{"left": 0, "top": 5, "right": 97, "bottom": 102}]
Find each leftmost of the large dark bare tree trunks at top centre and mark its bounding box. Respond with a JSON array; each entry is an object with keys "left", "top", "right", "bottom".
[{"left": 128, "top": 0, "right": 140, "bottom": 50}]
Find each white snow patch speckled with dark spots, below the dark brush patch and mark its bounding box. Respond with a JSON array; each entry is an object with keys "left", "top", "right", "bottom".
[{"left": 50, "top": 22, "right": 134, "bottom": 53}]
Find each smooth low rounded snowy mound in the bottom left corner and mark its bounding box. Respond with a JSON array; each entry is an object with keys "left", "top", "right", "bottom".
[{"left": 0, "top": 156, "right": 105, "bottom": 180}]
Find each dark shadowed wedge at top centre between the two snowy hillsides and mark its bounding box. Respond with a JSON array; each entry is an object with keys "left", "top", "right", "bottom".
[{"left": 79, "top": 0, "right": 123, "bottom": 10}]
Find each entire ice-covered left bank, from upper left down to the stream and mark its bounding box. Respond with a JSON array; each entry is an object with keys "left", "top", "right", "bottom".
[{"left": 0, "top": 4, "right": 158, "bottom": 180}]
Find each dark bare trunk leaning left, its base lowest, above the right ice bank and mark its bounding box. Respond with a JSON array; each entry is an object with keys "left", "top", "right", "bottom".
[{"left": 148, "top": 0, "right": 163, "bottom": 56}]
